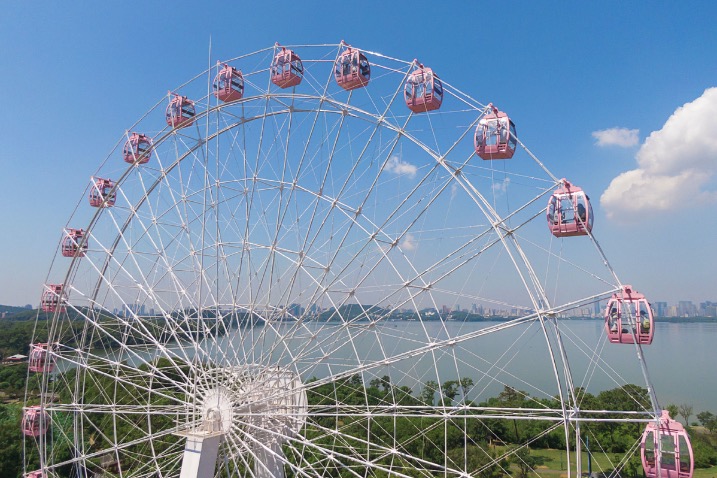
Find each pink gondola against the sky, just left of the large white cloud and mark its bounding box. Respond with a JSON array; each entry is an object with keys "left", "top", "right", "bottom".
[{"left": 547, "top": 179, "right": 594, "bottom": 237}]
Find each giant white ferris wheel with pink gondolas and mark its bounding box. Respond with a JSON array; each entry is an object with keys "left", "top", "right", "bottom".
[{"left": 23, "top": 42, "right": 692, "bottom": 478}]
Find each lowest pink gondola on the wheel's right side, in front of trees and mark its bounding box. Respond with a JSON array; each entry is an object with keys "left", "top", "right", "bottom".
[{"left": 640, "top": 410, "right": 695, "bottom": 478}]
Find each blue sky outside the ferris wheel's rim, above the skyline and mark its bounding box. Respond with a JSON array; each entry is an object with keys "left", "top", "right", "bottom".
[{"left": 0, "top": 1, "right": 717, "bottom": 305}]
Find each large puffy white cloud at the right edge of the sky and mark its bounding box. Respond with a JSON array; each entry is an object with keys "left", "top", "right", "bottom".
[{"left": 600, "top": 88, "right": 717, "bottom": 218}]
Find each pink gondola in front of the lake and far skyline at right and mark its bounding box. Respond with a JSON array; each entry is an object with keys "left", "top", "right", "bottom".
[{"left": 605, "top": 285, "right": 655, "bottom": 345}]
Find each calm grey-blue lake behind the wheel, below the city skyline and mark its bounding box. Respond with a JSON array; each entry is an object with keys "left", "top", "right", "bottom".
[{"left": 204, "top": 320, "right": 717, "bottom": 413}]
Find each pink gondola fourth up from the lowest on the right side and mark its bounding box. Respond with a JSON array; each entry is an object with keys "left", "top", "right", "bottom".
[{"left": 473, "top": 104, "right": 518, "bottom": 160}]
